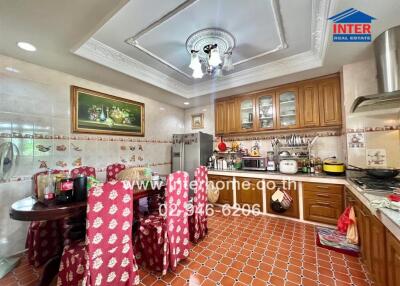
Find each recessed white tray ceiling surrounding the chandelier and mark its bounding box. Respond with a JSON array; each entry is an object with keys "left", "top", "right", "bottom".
[{"left": 75, "top": 0, "right": 322, "bottom": 98}]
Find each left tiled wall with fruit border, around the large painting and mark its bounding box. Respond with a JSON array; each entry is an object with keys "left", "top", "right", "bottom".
[{"left": 0, "top": 55, "right": 184, "bottom": 257}]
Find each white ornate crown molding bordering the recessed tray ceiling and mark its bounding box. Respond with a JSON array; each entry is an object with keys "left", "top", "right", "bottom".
[{"left": 75, "top": 0, "right": 335, "bottom": 98}]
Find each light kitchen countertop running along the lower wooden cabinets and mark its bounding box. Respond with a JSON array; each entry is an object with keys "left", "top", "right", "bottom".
[{"left": 208, "top": 170, "right": 400, "bottom": 240}]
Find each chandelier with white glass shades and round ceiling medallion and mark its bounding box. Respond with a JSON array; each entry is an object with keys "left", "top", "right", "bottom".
[{"left": 186, "top": 28, "right": 235, "bottom": 78}]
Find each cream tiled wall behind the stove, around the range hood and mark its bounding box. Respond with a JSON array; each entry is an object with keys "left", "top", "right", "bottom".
[{"left": 342, "top": 59, "right": 400, "bottom": 168}]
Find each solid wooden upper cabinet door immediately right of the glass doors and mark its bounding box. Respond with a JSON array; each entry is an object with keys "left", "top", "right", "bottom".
[{"left": 299, "top": 82, "right": 320, "bottom": 127}]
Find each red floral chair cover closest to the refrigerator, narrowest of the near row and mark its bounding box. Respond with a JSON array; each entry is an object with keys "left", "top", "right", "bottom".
[{"left": 189, "top": 166, "right": 208, "bottom": 243}]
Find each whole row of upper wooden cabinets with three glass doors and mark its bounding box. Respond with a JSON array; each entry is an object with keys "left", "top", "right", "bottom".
[{"left": 215, "top": 74, "right": 342, "bottom": 135}]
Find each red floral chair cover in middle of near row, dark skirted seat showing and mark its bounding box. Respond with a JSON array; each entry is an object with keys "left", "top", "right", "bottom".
[{"left": 138, "top": 171, "right": 189, "bottom": 275}]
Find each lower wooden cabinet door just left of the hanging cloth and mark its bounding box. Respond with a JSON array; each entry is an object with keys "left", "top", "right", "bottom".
[{"left": 236, "top": 178, "right": 263, "bottom": 211}]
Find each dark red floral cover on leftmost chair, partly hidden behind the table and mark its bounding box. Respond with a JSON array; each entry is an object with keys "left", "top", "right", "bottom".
[{"left": 25, "top": 170, "right": 64, "bottom": 267}]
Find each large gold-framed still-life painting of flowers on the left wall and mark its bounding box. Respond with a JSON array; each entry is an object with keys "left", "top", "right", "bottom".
[{"left": 71, "top": 86, "right": 144, "bottom": 136}]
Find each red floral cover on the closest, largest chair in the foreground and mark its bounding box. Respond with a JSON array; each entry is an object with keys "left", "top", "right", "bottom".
[{"left": 57, "top": 181, "right": 139, "bottom": 286}]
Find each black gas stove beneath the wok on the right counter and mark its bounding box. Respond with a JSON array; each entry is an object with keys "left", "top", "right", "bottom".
[{"left": 350, "top": 177, "right": 400, "bottom": 194}]
